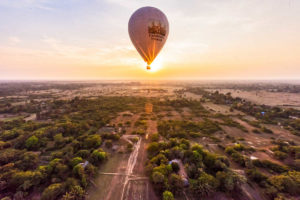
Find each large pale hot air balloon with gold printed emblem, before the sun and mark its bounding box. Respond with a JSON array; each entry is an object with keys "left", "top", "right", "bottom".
[{"left": 128, "top": 7, "right": 169, "bottom": 70}]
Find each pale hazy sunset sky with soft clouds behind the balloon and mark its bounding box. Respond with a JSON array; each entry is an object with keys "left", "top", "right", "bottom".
[{"left": 0, "top": 0, "right": 300, "bottom": 80}]
